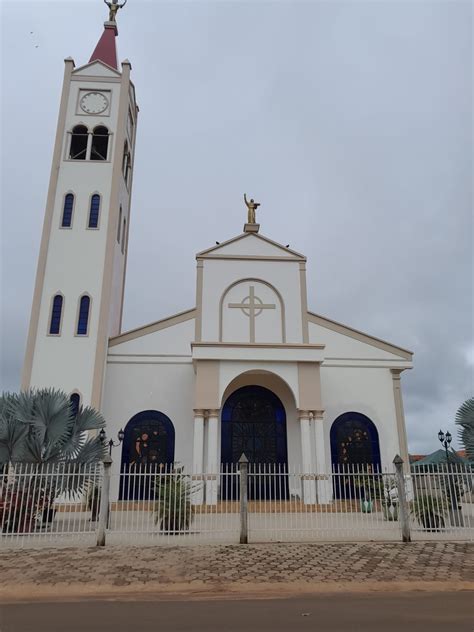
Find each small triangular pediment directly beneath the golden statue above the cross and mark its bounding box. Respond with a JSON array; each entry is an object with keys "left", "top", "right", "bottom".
[{"left": 196, "top": 233, "right": 306, "bottom": 261}]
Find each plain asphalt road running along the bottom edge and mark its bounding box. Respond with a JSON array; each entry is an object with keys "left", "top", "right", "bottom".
[{"left": 0, "top": 592, "right": 474, "bottom": 632}]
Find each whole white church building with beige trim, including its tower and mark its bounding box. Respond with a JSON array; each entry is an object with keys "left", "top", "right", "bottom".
[{"left": 22, "top": 12, "right": 412, "bottom": 502}]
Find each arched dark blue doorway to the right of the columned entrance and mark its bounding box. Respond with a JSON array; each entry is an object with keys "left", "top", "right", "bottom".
[{"left": 331, "top": 412, "right": 381, "bottom": 498}]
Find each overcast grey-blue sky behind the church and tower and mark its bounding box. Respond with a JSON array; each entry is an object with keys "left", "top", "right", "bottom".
[{"left": 1, "top": 0, "right": 474, "bottom": 453}]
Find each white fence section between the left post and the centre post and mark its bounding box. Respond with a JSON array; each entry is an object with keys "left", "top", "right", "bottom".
[{"left": 106, "top": 465, "right": 240, "bottom": 544}]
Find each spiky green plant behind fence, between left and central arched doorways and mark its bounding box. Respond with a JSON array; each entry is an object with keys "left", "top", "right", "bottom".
[{"left": 153, "top": 466, "right": 193, "bottom": 533}]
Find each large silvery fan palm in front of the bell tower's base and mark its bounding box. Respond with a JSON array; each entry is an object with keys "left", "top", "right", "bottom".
[{"left": 0, "top": 389, "right": 106, "bottom": 531}]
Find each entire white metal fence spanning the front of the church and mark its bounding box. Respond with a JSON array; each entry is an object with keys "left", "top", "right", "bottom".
[{"left": 0, "top": 460, "right": 474, "bottom": 547}]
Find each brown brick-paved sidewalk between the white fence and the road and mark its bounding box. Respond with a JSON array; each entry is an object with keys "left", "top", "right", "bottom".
[{"left": 0, "top": 542, "right": 474, "bottom": 601}]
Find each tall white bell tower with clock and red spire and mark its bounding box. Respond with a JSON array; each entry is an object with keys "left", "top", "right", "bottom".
[{"left": 22, "top": 8, "right": 138, "bottom": 409}]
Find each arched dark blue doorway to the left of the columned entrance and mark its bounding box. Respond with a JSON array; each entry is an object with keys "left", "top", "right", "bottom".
[{"left": 119, "top": 410, "right": 175, "bottom": 500}]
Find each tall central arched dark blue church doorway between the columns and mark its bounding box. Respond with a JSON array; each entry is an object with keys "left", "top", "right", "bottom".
[{"left": 221, "top": 385, "right": 288, "bottom": 499}]
